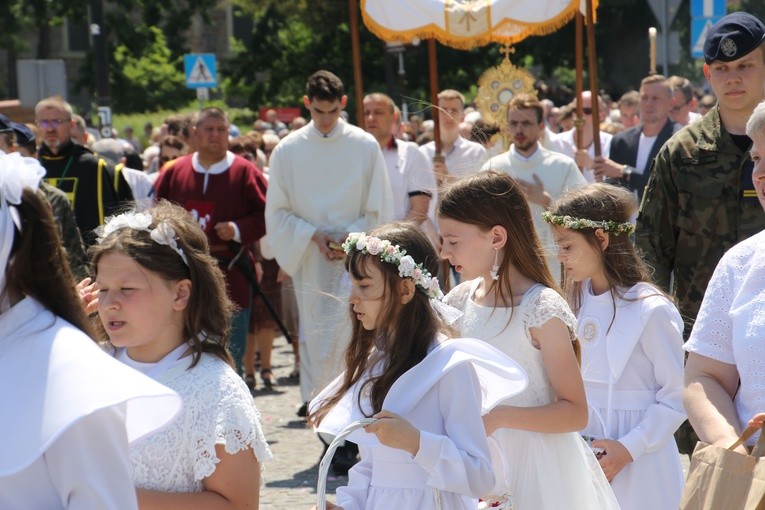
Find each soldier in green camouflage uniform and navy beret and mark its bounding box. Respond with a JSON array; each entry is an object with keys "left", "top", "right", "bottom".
[{"left": 635, "top": 12, "right": 765, "bottom": 453}]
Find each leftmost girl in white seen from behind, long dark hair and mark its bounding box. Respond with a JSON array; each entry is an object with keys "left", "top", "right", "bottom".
[{"left": 0, "top": 152, "right": 181, "bottom": 510}]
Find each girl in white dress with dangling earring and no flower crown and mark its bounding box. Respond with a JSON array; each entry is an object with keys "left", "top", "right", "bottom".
[{"left": 438, "top": 171, "right": 618, "bottom": 510}]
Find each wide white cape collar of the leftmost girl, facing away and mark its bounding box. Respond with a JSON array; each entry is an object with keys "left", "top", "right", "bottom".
[{"left": 0, "top": 297, "right": 182, "bottom": 476}]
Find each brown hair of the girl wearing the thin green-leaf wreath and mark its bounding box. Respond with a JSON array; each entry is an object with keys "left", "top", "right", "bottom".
[{"left": 550, "top": 182, "right": 671, "bottom": 320}]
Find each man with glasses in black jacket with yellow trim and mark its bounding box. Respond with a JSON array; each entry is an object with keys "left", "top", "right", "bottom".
[{"left": 35, "top": 97, "right": 133, "bottom": 245}]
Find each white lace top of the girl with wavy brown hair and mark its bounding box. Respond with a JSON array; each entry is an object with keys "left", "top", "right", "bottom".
[{"left": 130, "top": 354, "right": 271, "bottom": 492}]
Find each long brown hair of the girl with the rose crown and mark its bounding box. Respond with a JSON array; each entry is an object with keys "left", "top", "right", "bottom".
[{"left": 308, "top": 223, "right": 453, "bottom": 425}]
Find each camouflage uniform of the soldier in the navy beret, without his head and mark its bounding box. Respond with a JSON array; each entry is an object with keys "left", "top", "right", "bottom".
[{"left": 635, "top": 107, "right": 765, "bottom": 455}]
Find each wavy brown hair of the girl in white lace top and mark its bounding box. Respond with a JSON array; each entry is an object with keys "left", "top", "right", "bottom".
[{"left": 88, "top": 200, "right": 234, "bottom": 367}]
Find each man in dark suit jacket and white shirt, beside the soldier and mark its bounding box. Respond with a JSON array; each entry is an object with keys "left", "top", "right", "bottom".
[{"left": 595, "top": 74, "right": 681, "bottom": 199}]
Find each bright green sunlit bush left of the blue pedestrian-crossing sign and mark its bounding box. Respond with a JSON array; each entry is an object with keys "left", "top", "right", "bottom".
[{"left": 110, "top": 27, "right": 193, "bottom": 112}]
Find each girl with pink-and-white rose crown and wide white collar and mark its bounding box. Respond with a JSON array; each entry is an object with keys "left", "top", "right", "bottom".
[{"left": 309, "top": 224, "right": 526, "bottom": 510}]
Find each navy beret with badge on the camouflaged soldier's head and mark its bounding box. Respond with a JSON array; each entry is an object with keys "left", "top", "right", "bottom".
[{"left": 704, "top": 11, "right": 765, "bottom": 64}]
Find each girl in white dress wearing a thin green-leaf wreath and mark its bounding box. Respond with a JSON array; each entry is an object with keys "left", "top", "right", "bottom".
[{"left": 544, "top": 183, "right": 686, "bottom": 510}]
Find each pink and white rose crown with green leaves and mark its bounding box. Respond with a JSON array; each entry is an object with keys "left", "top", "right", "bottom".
[{"left": 343, "top": 232, "right": 444, "bottom": 299}]
